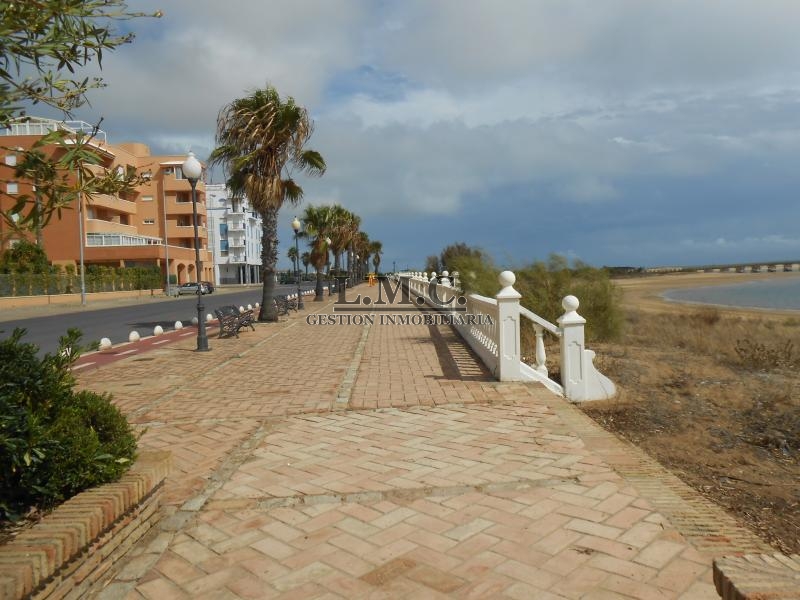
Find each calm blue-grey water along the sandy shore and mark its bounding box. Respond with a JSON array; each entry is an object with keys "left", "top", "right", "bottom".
[{"left": 662, "top": 273, "right": 800, "bottom": 310}]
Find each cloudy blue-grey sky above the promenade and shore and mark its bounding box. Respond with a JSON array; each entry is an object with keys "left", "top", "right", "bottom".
[{"left": 44, "top": 0, "right": 800, "bottom": 270}]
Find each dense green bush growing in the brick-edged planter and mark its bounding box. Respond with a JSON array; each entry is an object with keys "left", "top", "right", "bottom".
[{"left": 0, "top": 329, "right": 136, "bottom": 518}]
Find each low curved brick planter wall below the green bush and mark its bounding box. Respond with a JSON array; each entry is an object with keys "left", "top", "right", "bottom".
[{"left": 0, "top": 451, "right": 170, "bottom": 600}]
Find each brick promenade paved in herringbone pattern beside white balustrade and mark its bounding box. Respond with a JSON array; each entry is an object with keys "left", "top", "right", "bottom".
[{"left": 79, "top": 287, "right": 769, "bottom": 600}]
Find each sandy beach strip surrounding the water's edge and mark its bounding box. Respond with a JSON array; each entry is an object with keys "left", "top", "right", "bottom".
[{"left": 614, "top": 271, "right": 800, "bottom": 317}]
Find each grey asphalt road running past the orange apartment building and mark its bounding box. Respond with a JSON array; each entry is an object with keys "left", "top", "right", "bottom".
[{"left": 0, "top": 282, "right": 313, "bottom": 355}]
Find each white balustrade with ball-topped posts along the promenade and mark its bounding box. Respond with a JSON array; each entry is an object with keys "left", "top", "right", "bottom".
[{"left": 396, "top": 271, "right": 616, "bottom": 402}]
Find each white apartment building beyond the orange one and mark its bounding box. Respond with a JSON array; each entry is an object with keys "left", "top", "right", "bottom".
[{"left": 206, "top": 183, "right": 261, "bottom": 285}]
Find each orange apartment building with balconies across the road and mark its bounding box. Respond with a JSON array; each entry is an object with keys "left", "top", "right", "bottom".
[{"left": 0, "top": 118, "right": 216, "bottom": 284}]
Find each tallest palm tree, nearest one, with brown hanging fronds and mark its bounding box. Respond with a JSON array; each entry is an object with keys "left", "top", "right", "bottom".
[{"left": 209, "top": 86, "right": 325, "bottom": 321}]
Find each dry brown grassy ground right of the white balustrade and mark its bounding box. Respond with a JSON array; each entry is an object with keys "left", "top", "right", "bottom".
[{"left": 583, "top": 309, "right": 800, "bottom": 552}]
